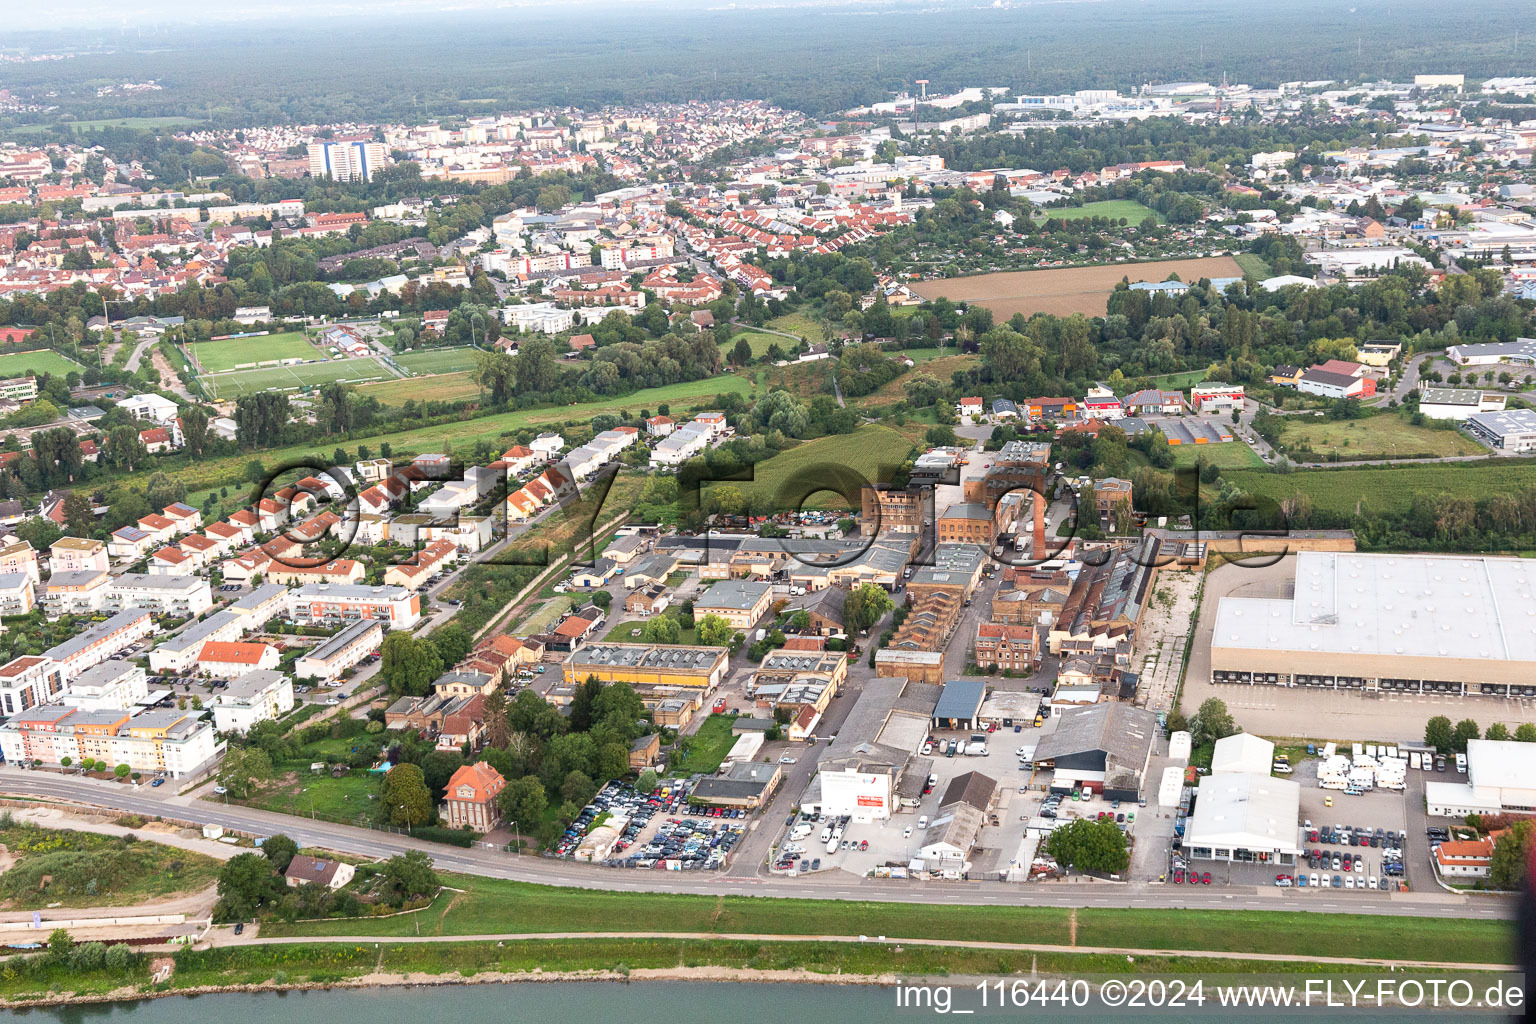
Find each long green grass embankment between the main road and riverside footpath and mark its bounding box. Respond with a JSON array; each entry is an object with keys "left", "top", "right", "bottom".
[{"left": 261, "top": 875, "right": 1514, "bottom": 967}]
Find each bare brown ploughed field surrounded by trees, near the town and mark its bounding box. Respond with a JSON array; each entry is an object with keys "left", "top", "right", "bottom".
[{"left": 912, "top": 256, "right": 1243, "bottom": 321}]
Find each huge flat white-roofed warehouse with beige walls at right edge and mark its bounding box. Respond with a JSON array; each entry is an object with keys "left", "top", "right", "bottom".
[{"left": 1210, "top": 551, "right": 1536, "bottom": 695}]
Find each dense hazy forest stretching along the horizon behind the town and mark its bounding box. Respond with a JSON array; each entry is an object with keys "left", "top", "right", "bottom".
[{"left": 0, "top": 0, "right": 1536, "bottom": 126}]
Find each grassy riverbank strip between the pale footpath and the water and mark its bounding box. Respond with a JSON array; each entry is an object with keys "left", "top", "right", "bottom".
[{"left": 0, "top": 938, "right": 1499, "bottom": 1009}]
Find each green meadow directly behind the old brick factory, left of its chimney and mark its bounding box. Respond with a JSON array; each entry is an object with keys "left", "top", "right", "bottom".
[{"left": 711, "top": 424, "right": 912, "bottom": 510}]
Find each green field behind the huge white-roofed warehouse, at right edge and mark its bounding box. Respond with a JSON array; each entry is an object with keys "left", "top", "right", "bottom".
[{"left": 1226, "top": 459, "right": 1536, "bottom": 516}]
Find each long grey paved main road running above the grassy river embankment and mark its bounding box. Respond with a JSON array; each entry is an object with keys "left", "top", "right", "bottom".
[{"left": 0, "top": 768, "right": 1514, "bottom": 920}]
